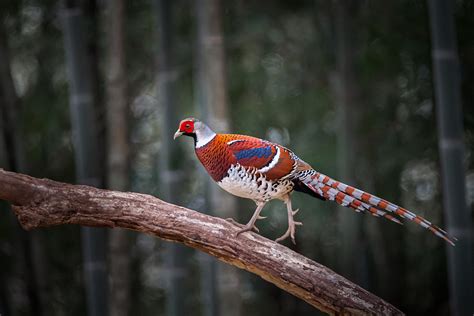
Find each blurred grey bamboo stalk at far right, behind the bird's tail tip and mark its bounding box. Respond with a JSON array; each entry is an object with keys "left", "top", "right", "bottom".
[{"left": 428, "top": 0, "right": 474, "bottom": 315}]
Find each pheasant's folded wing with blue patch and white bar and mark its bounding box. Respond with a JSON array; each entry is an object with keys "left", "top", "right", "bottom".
[{"left": 227, "top": 135, "right": 296, "bottom": 180}]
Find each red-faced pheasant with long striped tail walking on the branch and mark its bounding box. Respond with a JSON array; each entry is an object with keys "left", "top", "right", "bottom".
[{"left": 174, "top": 117, "right": 456, "bottom": 246}]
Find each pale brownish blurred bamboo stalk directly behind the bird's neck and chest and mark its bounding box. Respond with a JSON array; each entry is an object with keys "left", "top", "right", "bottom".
[{"left": 194, "top": 0, "right": 242, "bottom": 316}]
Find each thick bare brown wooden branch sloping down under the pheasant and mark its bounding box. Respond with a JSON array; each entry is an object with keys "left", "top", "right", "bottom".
[{"left": 0, "top": 169, "right": 402, "bottom": 315}]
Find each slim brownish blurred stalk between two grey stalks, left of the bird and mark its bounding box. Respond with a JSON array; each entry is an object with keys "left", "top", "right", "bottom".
[{"left": 104, "top": 0, "right": 132, "bottom": 316}]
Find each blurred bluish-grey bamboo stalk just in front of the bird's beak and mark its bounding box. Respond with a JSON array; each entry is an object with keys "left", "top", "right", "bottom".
[{"left": 154, "top": 0, "right": 190, "bottom": 316}]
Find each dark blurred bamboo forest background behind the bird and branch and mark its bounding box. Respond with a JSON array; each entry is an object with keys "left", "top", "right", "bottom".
[{"left": 0, "top": 0, "right": 474, "bottom": 316}]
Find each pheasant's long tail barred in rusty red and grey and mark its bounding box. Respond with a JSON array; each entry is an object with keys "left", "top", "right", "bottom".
[{"left": 299, "top": 170, "right": 457, "bottom": 246}]
